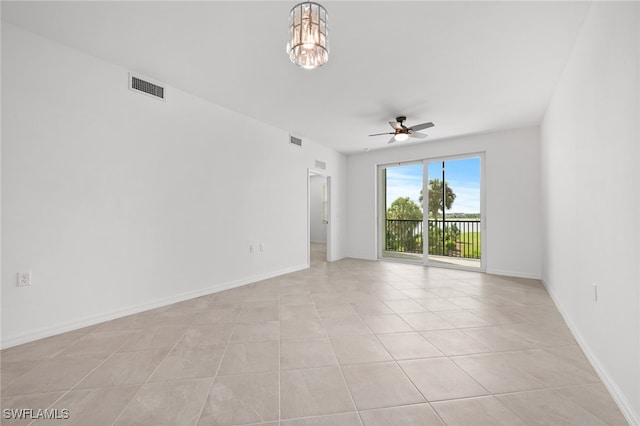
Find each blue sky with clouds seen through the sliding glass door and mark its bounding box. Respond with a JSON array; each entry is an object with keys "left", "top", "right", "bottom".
[{"left": 387, "top": 157, "right": 480, "bottom": 213}]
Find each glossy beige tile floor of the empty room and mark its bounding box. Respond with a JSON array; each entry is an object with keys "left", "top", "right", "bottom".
[{"left": 1, "top": 246, "right": 627, "bottom": 426}]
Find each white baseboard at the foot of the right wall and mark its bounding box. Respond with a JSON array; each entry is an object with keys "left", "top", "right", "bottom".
[{"left": 542, "top": 280, "right": 640, "bottom": 426}]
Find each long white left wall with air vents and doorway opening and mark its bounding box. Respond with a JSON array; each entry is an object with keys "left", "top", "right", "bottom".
[{"left": 2, "top": 23, "right": 346, "bottom": 347}]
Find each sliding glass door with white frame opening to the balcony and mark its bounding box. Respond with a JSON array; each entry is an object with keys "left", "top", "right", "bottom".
[{"left": 378, "top": 155, "right": 484, "bottom": 269}]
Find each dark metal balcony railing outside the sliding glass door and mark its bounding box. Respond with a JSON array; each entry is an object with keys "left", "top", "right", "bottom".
[{"left": 385, "top": 219, "right": 482, "bottom": 259}]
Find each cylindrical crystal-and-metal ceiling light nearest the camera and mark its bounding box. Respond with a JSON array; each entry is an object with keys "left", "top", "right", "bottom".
[{"left": 287, "top": 1, "right": 329, "bottom": 69}]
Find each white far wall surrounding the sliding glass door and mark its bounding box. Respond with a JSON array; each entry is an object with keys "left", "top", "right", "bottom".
[{"left": 348, "top": 128, "right": 541, "bottom": 278}]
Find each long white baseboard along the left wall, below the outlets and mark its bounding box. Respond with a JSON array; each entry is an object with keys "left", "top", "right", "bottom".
[{"left": 0, "top": 264, "right": 309, "bottom": 349}]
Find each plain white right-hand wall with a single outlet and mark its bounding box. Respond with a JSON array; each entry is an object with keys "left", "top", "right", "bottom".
[{"left": 541, "top": 2, "right": 640, "bottom": 424}]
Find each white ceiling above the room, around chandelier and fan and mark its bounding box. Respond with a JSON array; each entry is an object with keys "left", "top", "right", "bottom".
[{"left": 2, "top": 1, "right": 589, "bottom": 153}]
